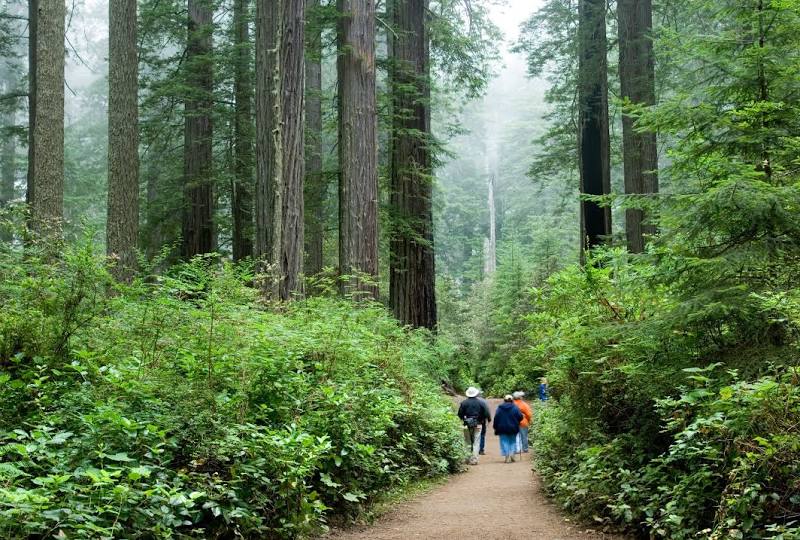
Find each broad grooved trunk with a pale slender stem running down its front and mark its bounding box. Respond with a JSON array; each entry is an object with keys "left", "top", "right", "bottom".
[{"left": 256, "top": 0, "right": 305, "bottom": 300}]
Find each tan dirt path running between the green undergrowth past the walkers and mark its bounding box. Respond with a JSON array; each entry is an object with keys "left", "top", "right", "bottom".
[{"left": 326, "top": 400, "right": 623, "bottom": 540}]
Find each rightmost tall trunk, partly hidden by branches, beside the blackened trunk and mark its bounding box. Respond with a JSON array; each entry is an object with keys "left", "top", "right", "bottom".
[{"left": 617, "top": 0, "right": 658, "bottom": 253}]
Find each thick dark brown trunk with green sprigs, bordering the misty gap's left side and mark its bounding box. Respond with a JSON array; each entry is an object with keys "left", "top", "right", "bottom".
[{"left": 389, "top": 0, "right": 436, "bottom": 330}]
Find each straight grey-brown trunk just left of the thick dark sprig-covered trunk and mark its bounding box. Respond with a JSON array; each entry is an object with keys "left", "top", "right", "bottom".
[{"left": 337, "top": 0, "right": 378, "bottom": 298}]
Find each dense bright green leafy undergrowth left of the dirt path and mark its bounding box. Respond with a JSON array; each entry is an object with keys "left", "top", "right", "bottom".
[{"left": 0, "top": 238, "right": 463, "bottom": 538}]
